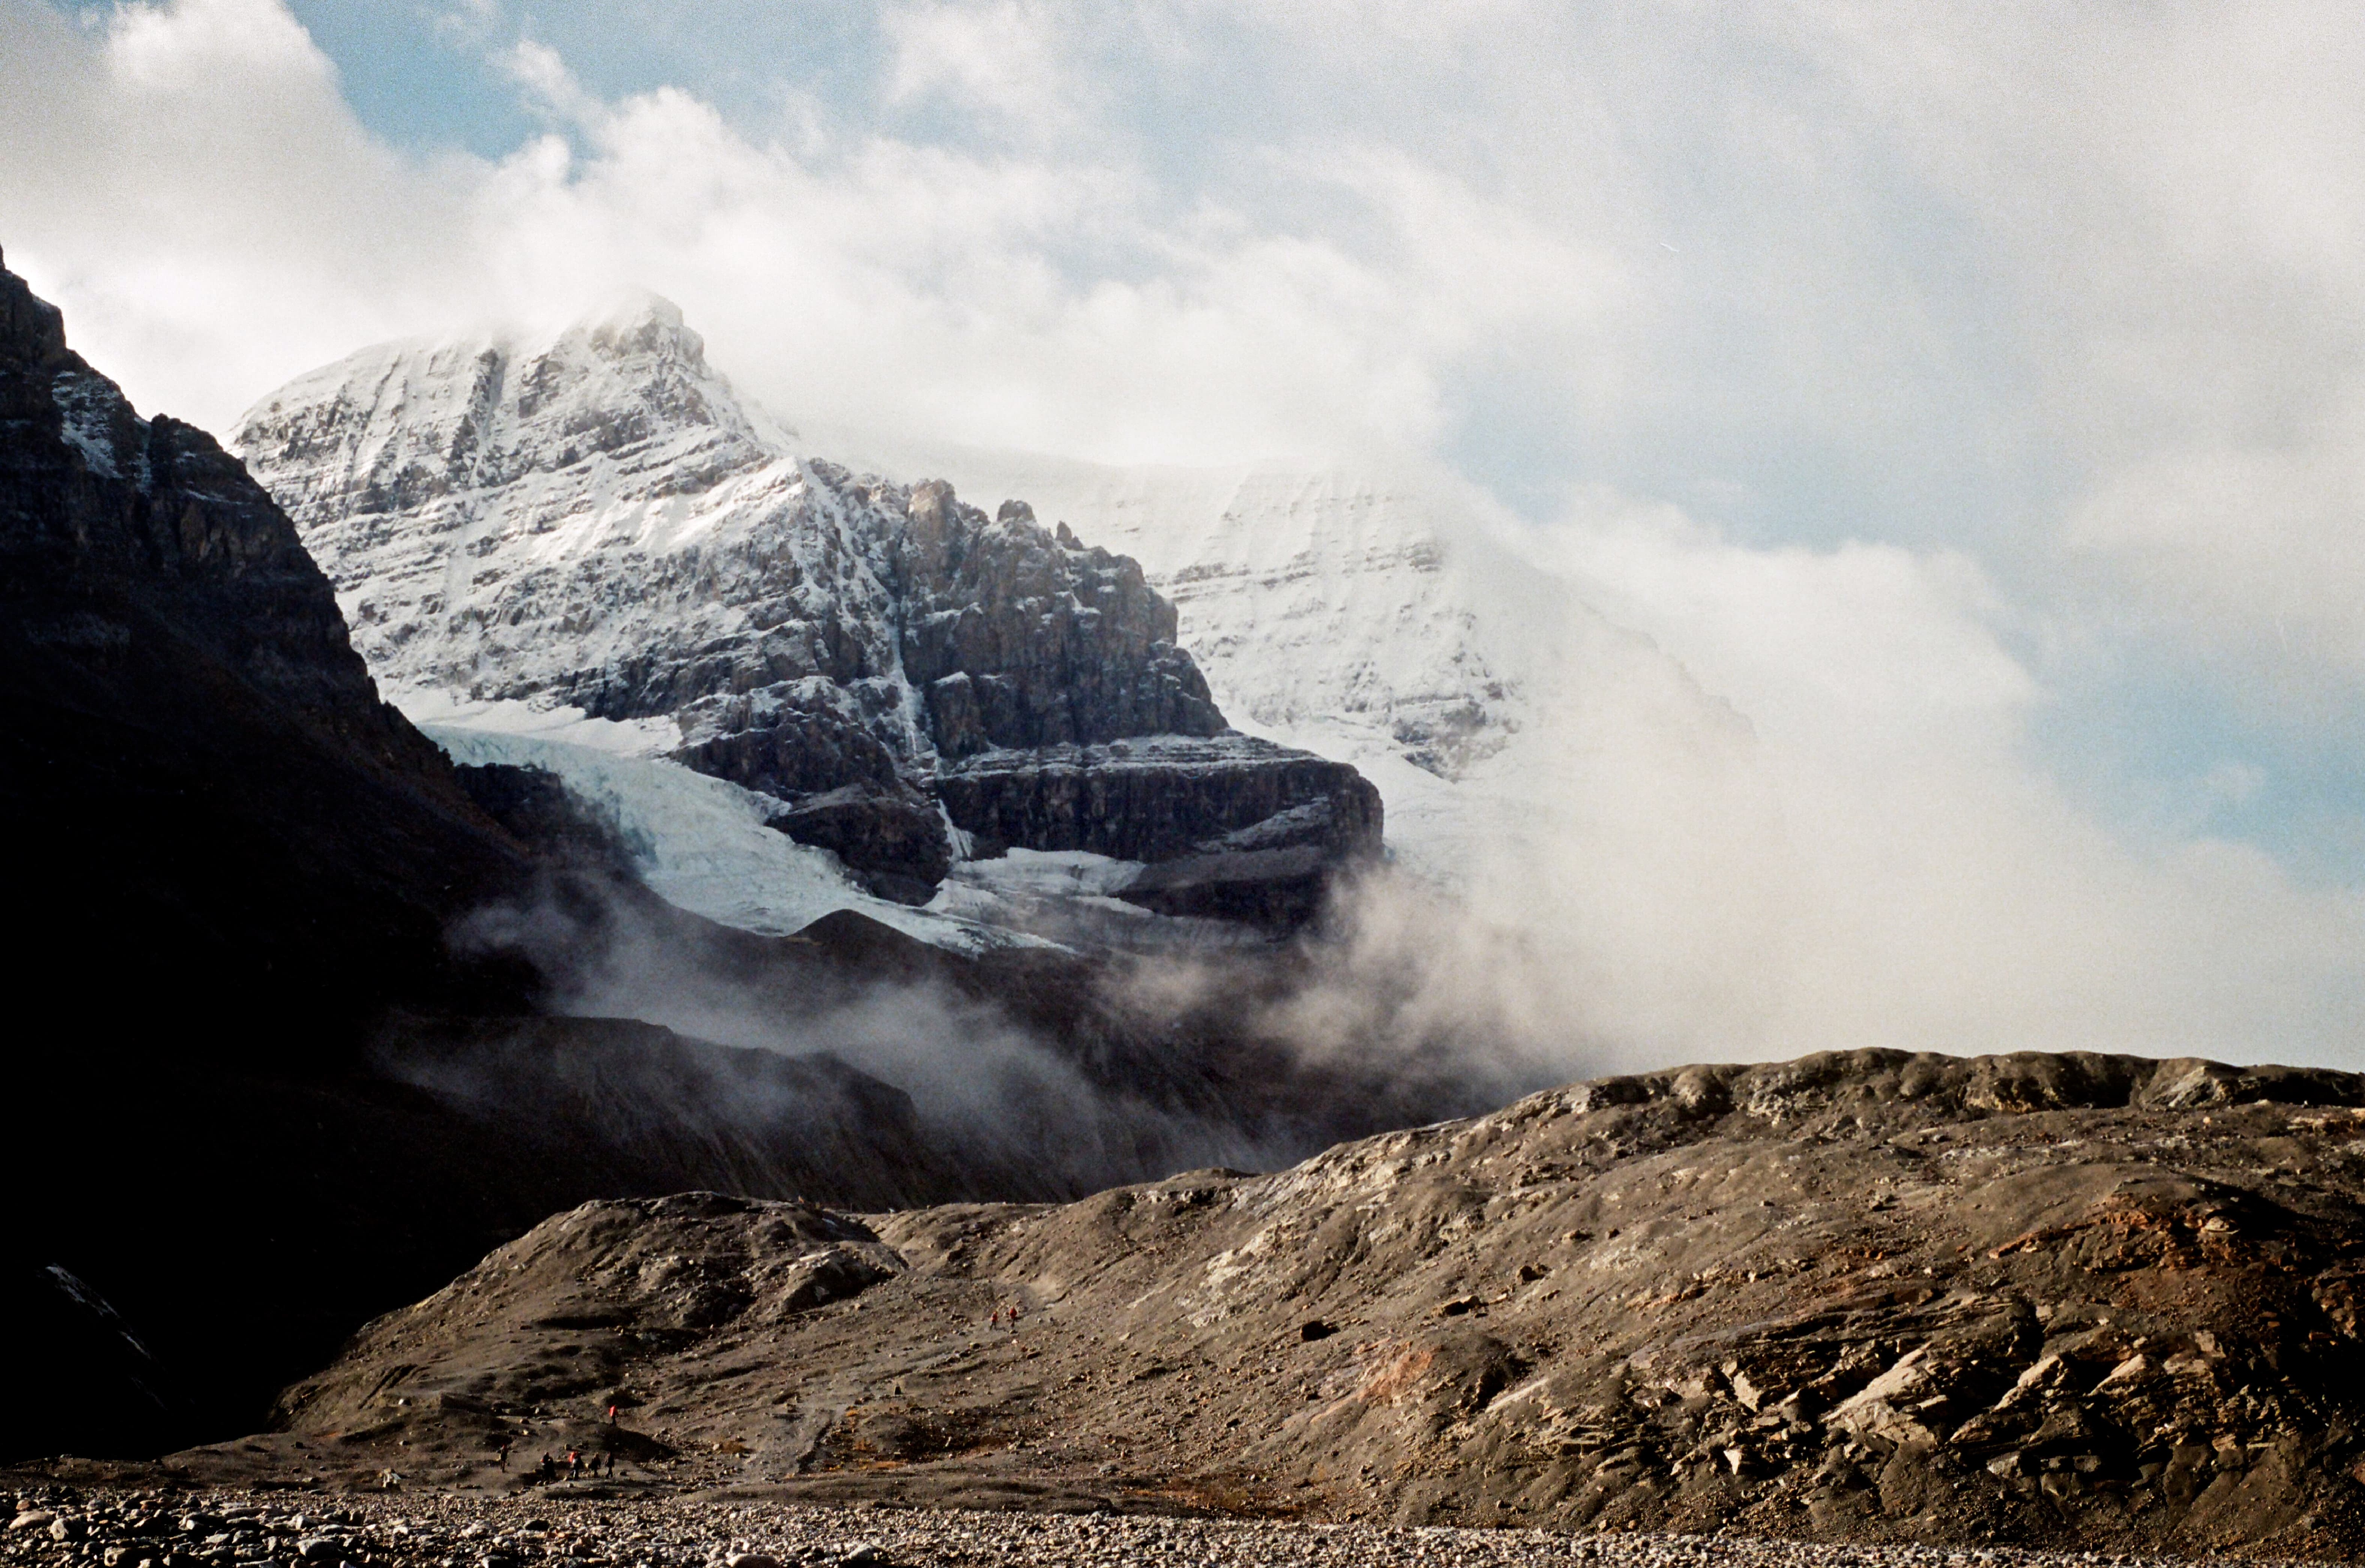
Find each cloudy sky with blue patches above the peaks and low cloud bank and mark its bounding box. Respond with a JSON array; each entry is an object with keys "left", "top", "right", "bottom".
[{"left": 14, "top": 0, "right": 2365, "bottom": 1055}]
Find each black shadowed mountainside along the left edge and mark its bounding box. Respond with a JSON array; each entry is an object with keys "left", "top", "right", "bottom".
[{"left": 0, "top": 246, "right": 544, "bottom": 1454}]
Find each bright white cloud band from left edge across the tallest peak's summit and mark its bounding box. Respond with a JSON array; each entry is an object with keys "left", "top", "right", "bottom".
[{"left": 0, "top": 0, "right": 1504, "bottom": 459}]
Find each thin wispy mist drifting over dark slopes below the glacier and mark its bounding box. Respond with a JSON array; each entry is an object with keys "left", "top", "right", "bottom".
[{"left": 433, "top": 878, "right": 1509, "bottom": 1199}]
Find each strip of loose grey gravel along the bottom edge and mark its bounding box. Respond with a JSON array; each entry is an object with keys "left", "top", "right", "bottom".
[{"left": 0, "top": 1490, "right": 2317, "bottom": 1568}]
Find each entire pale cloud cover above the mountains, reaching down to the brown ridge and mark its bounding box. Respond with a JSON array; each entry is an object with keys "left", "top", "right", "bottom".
[{"left": 0, "top": 0, "right": 2365, "bottom": 1067}]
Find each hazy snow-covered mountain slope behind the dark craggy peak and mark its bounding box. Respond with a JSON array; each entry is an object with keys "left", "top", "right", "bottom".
[{"left": 842, "top": 442, "right": 1755, "bottom": 929}]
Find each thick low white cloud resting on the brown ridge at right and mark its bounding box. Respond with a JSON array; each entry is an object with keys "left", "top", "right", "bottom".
[{"left": 1426, "top": 497, "right": 2365, "bottom": 1067}]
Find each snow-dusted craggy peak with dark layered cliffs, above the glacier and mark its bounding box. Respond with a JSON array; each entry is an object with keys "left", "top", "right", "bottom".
[{"left": 234, "top": 300, "right": 1379, "bottom": 922}]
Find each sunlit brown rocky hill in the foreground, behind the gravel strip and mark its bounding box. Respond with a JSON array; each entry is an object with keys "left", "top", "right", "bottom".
[{"left": 74, "top": 1052, "right": 2365, "bottom": 1559}]
